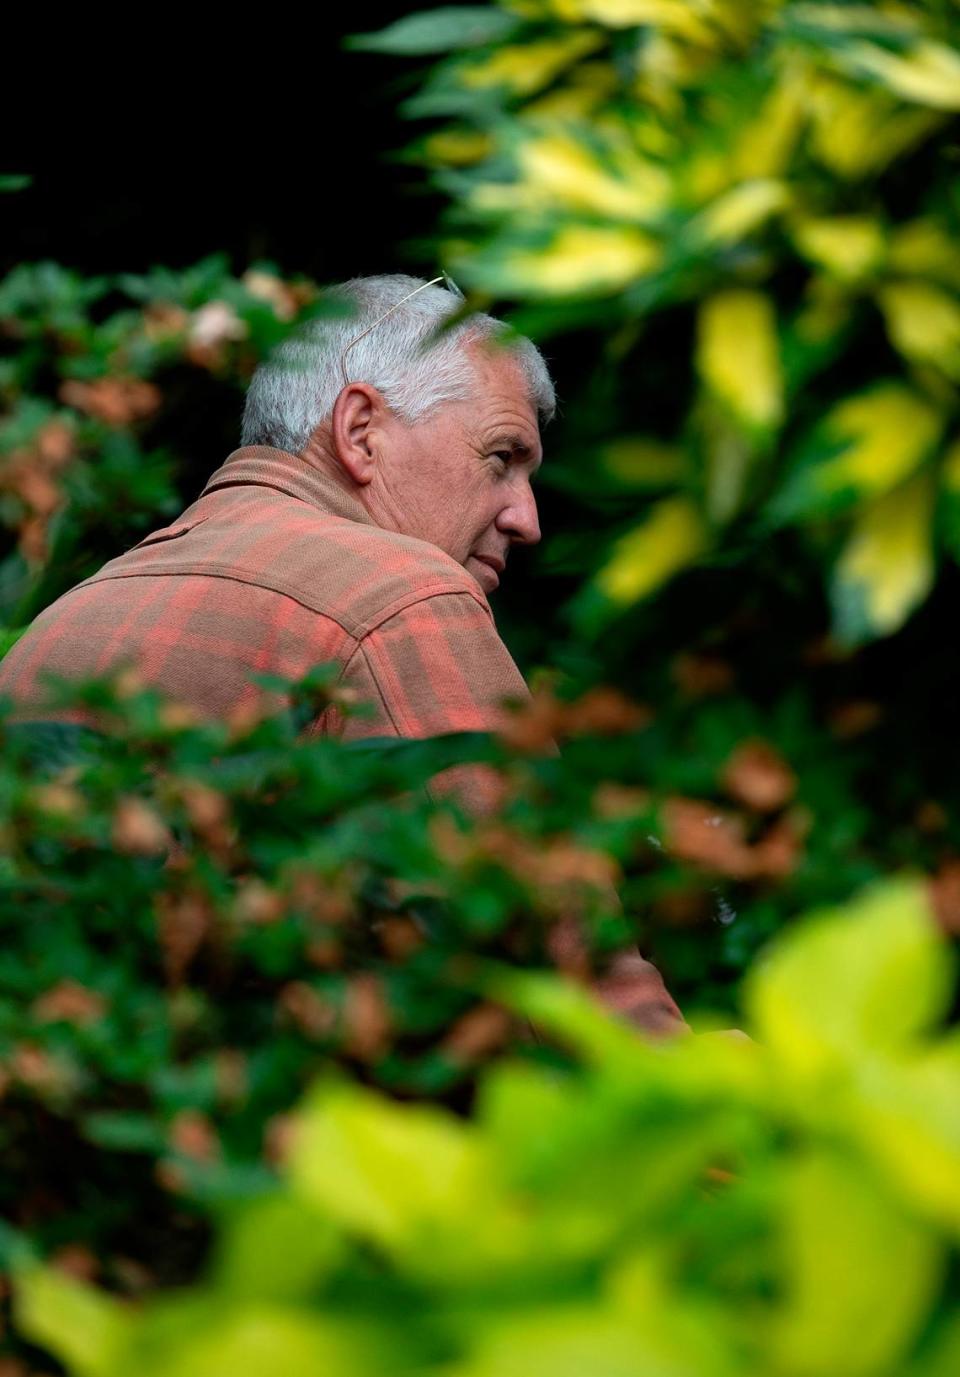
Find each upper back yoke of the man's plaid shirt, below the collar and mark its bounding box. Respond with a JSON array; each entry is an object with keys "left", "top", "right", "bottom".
[{"left": 83, "top": 487, "right": 490, "bottom": 638}]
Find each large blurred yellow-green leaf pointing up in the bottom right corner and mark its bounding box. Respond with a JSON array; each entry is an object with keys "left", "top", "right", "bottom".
[{"left": 773, "top": 1151, "right": 942, "bottom": 1377}]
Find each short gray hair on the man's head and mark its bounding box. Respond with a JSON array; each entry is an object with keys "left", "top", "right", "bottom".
[{"left": 241, "top": 273, "right": 556, "bottom": 454}]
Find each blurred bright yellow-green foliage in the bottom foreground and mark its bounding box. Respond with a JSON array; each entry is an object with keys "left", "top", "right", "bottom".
[{"left": 15, "top": 883, "right": 960, "bottom": 1377}]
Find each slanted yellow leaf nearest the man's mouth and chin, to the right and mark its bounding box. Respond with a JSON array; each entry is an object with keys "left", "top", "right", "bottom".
[{"left": 595, "top": 497, "right": 708, "bottom": 606}]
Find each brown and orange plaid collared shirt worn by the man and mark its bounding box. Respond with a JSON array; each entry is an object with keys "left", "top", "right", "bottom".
[{"left": 0, "top": 446, "right": 526, "bottom": 737}]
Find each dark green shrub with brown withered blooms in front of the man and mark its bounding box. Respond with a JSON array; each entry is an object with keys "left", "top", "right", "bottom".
[{"left": 0, "top": 668, "right": 710, "bottom": 1289}]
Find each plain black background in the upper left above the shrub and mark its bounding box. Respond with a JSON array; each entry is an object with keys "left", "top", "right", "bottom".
[{"left": 0, "top": 3, "right": 439, "bottom": 282}]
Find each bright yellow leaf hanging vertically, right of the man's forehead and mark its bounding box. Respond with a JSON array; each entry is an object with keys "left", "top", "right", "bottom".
[{"left": 697, "top": 291, "right": 784, "bottom": 430}]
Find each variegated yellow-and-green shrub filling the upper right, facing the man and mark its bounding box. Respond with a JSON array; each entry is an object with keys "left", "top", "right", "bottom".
[{"left": 359, "top": 0, "right": 960, "bottom": 990}]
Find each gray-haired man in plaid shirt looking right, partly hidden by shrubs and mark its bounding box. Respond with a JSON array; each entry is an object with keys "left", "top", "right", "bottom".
[{"left": 0, "top": 275, "right": 679, "bottom": 1026}]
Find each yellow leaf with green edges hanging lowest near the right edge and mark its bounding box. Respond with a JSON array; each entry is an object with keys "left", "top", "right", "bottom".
[{"left": 833, "top": 472, "right": 934, "bottom": 642}]
